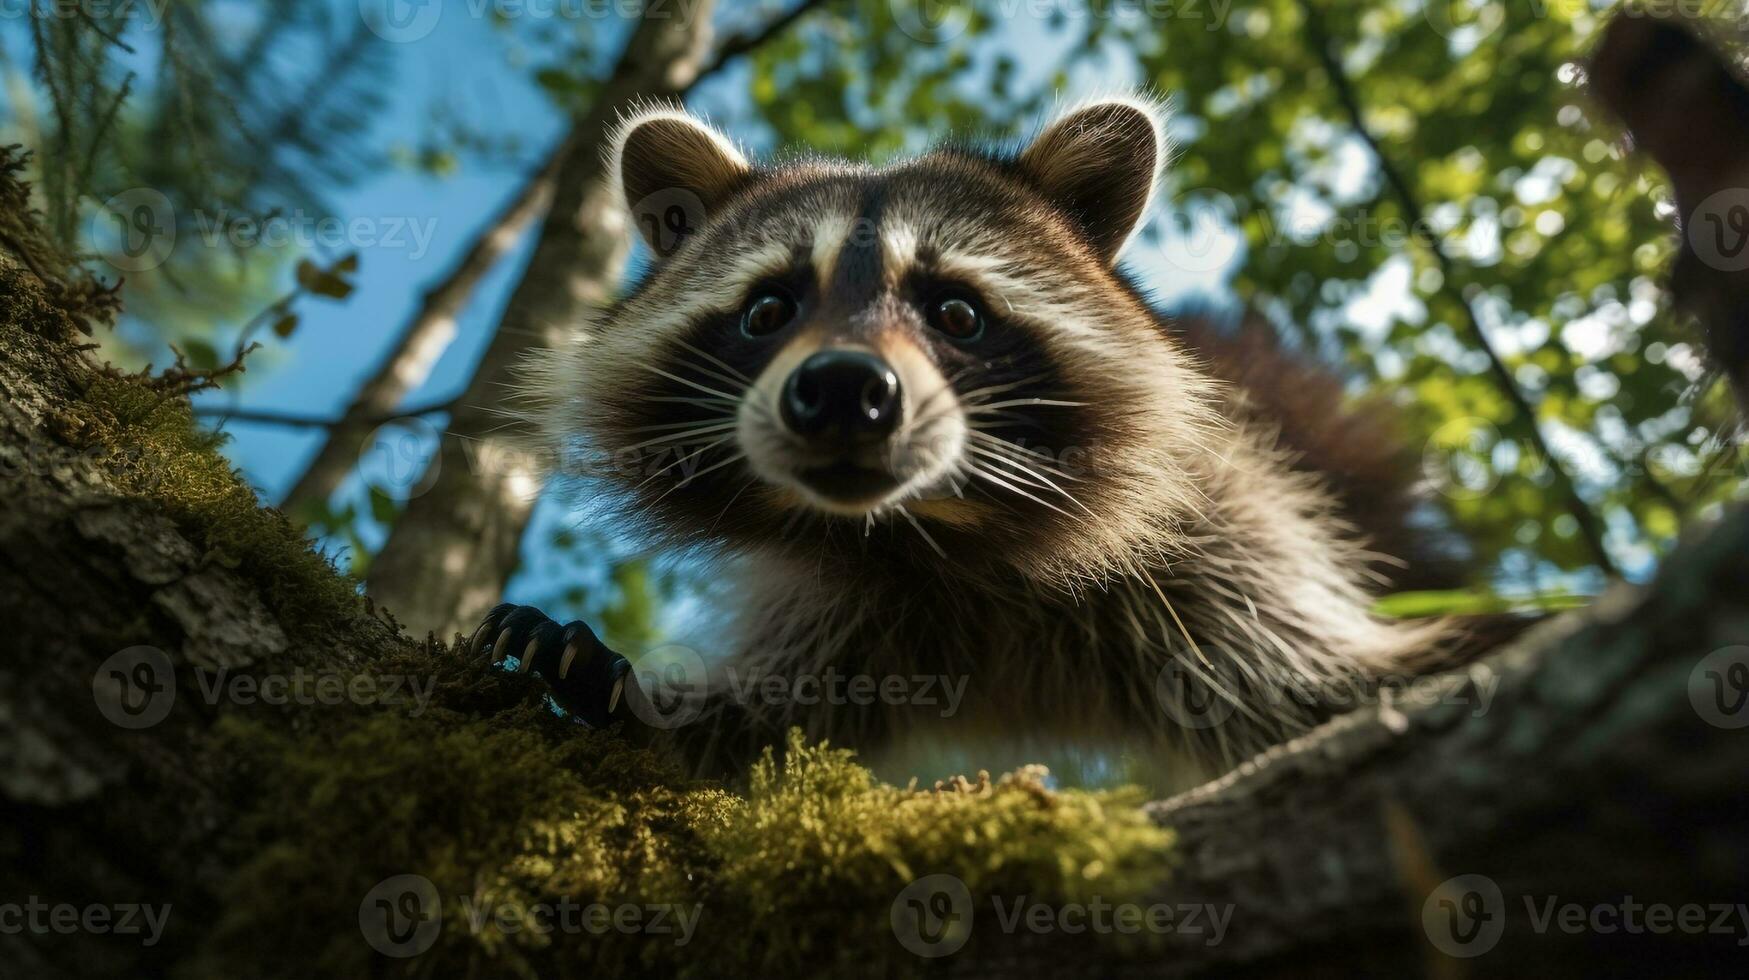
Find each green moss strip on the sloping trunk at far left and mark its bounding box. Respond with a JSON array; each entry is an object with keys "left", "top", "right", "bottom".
[{"left": 59, "top": 373, "right": 362, "bottom": 632}]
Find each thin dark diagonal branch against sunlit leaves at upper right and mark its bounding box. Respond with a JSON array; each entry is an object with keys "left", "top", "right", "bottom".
[{"left": 1298, "top": 0, "right": 1618, "bottom": 576}]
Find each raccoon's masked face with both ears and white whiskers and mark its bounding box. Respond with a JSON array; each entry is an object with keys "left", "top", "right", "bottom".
[{"left": 539, "top": 100, "right": 1210, "bottom": 569}]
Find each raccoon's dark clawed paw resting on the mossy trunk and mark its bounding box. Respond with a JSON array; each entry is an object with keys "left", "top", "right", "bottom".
[{"left": 467, "top": 602, "right": 631, "bottom": 728}]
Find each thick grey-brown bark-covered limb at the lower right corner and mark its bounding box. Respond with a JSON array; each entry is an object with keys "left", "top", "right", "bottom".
[{"left": 972, "top": 511, "right": 1749, "bottom": 977}]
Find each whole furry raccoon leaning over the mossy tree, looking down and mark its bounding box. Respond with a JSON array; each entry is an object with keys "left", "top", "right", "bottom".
[{"left": 470, "top": 98, "right": 1460, "bottom": 777}]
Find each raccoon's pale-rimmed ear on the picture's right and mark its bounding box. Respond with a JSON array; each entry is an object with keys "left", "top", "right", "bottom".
[{"left": 1020, "top": 100, "right": 1167, "bottom": 263}]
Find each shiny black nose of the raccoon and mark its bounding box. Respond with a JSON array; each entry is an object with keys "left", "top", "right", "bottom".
[{"left": 782, "top": 348, "right": 901, "bottom": 443}]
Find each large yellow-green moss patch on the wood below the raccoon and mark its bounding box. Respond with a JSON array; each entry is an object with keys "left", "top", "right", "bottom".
[{"left": 189, "top": 651, "right": 1170, "bottom": 977}]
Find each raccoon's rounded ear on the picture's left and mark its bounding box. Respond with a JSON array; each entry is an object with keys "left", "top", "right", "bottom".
[{"left": 610, "top": 109, "right": 750, "bottom": 256}]
